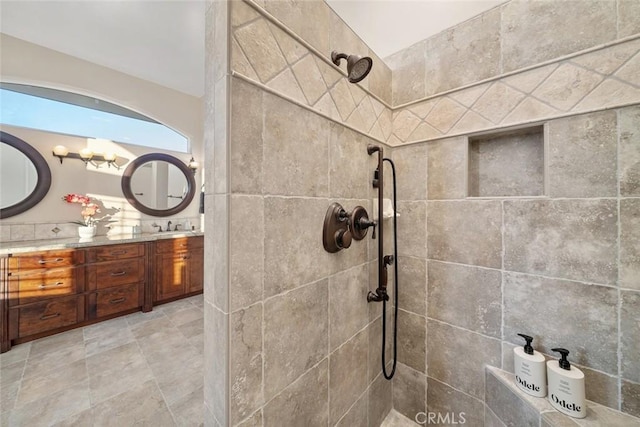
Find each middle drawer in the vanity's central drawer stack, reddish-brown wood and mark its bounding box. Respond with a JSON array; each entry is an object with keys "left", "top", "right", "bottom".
[{"left": 86, "top": 258, "right": 144, "bottom": 290}]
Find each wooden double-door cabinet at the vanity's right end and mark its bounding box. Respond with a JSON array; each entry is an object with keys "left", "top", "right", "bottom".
[{"left": 154, "top": 236, "right": 204, "bottom": 302}]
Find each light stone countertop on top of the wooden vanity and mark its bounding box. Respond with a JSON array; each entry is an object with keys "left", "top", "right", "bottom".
[{"left": 0, "top": 231, "right": 204, "bottom": 256}]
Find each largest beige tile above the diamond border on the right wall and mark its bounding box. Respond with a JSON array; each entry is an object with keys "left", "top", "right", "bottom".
[{"left": 502, "top": 1, "right": 616, "bottom": 72}]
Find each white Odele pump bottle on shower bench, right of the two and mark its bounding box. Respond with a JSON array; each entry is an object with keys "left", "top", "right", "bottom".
[{"left": 547, "top": 348, "right": 587, "bottom": 418}]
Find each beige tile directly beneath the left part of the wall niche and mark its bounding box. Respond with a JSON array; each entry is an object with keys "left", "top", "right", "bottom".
[{"left": 427, "top": 200, "right": 502, "bottom": 268}]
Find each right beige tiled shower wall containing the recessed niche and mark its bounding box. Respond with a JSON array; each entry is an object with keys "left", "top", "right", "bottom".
[{"left": 389, "top": 1, "right": 640, "bottom": 425}]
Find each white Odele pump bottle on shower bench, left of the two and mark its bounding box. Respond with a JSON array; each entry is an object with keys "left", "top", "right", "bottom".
[{"left": 513, "top": 334, "right": 547, "bottom": 397}]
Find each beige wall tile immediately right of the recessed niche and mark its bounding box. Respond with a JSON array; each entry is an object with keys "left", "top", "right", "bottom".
[{"left": 548, "top": 111, "right": 618, "bottom": 197}]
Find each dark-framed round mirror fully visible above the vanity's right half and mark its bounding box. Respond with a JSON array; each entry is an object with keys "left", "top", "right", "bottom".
[{"left": 122, "top": 153, "right": 195, "bottom": 216}]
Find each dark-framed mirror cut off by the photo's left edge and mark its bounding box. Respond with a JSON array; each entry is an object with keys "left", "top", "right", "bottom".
[{"left": 0, "top": 131, "right": 51, "bottom": 219}]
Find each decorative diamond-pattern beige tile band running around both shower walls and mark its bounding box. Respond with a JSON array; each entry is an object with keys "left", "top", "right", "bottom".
[{"left": 231, "top": 0, "right": 640, "bottom": 146}]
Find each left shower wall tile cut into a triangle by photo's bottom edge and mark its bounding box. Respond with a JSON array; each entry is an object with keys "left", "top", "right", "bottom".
[{"left": 263, "top": 359, "right": 329, "bottom": 426}]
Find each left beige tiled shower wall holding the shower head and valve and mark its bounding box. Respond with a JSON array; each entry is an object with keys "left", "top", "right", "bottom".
[{"left": 205, "top": 1, "right": 392, "bottom": 426}]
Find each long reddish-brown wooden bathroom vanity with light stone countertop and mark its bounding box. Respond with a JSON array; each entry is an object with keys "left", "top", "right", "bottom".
[{"left": 0, "top": 232, "right": 204, "bottom": 352}]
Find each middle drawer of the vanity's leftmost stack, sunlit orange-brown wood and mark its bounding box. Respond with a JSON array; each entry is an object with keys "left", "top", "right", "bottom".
[{"left": 9, "top": 267, "right": 84, "bottom": 307}]
